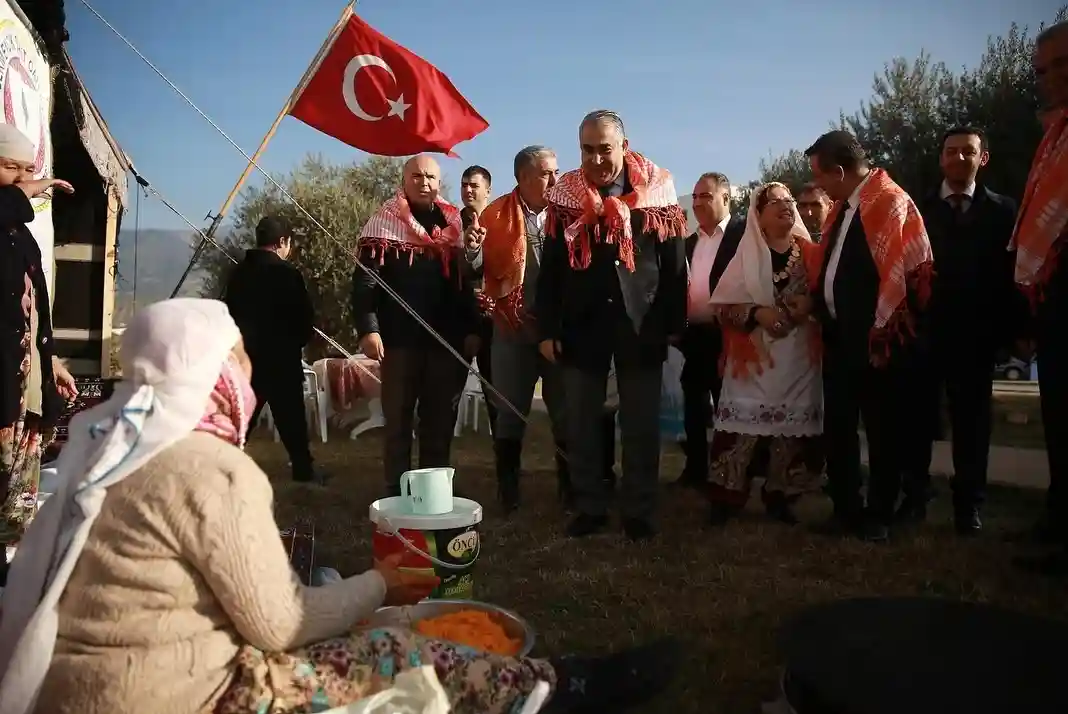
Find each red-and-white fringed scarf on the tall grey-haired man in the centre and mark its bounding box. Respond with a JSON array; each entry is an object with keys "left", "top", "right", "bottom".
[{"left": 546, "top": 150, "right": 686, "bottom": 271}]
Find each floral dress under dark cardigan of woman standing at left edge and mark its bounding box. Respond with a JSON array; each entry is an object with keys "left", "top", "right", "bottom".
[{"left": 0, "top": 297, "right": 56, "bottom": 545}]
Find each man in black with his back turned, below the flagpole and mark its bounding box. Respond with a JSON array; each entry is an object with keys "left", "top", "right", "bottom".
[{"left": 218, "top": 217, "right": 317, "bottom": 481}]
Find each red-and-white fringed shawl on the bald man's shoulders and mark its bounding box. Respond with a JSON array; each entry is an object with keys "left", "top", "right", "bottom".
[{"left": 359, "top": 191, "right": 462, "bottom": 266}]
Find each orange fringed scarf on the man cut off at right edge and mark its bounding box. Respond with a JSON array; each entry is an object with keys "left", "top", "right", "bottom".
[{"left": 1009, "top": 110, "right": 1068, "bottom": 310}]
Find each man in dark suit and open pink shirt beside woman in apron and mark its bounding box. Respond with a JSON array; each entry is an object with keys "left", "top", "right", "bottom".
[{"left": 673, "top": 172, "right": 745, "bottom": 488}]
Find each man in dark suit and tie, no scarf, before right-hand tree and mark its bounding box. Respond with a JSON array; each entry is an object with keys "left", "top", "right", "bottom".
[{"left": 898, "top": 126, "right": 1027, "bottom": 535}]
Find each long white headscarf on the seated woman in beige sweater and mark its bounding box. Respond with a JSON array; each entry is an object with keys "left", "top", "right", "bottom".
[{"left": 0, "top": 298, "right": 241, "bottom": 714}]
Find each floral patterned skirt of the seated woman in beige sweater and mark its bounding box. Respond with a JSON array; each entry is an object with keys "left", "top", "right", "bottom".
[{"left": 215, "top": 628, "right": 556, "bottom": 714}]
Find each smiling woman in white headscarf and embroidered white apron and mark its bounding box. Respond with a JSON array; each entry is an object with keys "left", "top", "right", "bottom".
[{"left": 709, "top": 183, "right": 823, "bottom": 524}]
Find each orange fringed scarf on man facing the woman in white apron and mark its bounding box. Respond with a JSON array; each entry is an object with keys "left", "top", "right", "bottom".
[{"left": 816, "top": 169, "right": 935, "bottom": 359}]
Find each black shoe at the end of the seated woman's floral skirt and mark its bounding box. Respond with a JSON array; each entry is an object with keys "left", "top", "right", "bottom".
[{"left": 543, "top": 638, "right": 679, "bottom": 714}]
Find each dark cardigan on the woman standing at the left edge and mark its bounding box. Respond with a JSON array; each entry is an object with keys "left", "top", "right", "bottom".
[{"left": 0, "top": 186, "right": 64, "bottom": 427}]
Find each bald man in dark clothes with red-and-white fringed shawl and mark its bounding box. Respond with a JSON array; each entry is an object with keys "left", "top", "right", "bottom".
[{"left": 352, "top": 156, "right": 478, "bottom": 495}]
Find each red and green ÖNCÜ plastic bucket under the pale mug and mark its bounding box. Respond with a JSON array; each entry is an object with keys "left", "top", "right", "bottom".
[{"left": 370, "top": 496, "right": 482, "bottom": 600}]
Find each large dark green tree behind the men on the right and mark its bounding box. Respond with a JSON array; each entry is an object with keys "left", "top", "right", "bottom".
[{"left": 754, "top": 6, "right": 1068, "bottom": 199}]
